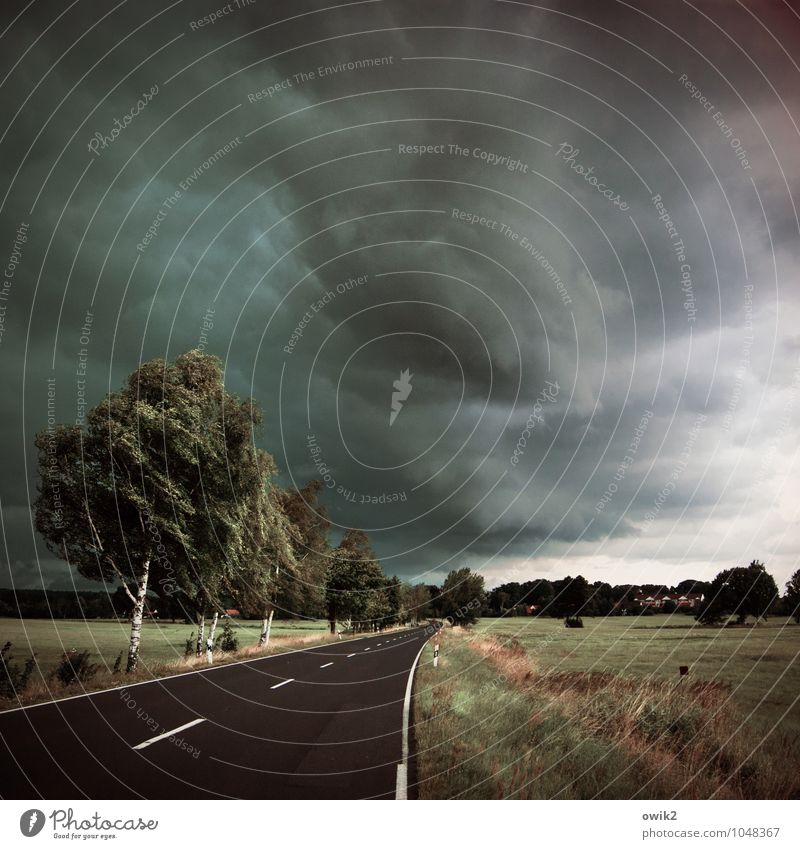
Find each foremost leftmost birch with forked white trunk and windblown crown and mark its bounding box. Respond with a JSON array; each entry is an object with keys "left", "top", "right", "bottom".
[{"left": 33, "top": 363, "right": 193, "bottom": 672}]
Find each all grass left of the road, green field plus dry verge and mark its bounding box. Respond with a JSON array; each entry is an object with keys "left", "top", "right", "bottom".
[{"left": 0, "top": 619, "right": 366, "bottom": 711}]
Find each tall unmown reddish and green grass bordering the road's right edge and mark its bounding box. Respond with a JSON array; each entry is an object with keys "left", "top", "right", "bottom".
[{"left": 414, "top": 625, "right": 800, "bottom": 799}]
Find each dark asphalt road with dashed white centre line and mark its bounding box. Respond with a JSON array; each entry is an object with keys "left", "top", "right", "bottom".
[{"left": 0, "top": 628, "right": 427, "bottom": 799}]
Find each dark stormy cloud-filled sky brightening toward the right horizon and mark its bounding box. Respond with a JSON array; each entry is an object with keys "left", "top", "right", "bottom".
[{"left": 0, "top": 0, "right": 800, "bottom": 587}]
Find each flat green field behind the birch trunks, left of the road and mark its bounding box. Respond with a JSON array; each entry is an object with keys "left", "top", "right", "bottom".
[{"left": 0, "top": 619, "right": 328, "bottom": 670}]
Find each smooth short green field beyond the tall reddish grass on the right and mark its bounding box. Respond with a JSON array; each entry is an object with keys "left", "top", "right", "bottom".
[{"left": 476, "top": 614, "right": 800, "bottom": 735}]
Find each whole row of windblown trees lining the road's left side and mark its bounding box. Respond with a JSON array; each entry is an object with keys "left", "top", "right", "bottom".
[{"left": 33, "top": 351, "right": 438, "bottom": 671}]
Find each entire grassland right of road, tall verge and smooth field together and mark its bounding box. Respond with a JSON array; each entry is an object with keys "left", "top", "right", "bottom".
[{"left": 414, "top": 616, "right": 800, "bottom": 799}]
